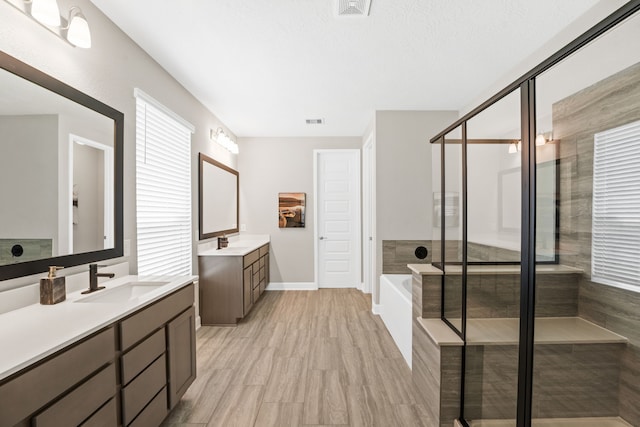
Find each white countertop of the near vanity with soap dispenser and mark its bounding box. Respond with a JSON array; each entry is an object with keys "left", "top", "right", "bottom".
[{"left": 0, "top": 276, "right": 198, "bottom": 380}]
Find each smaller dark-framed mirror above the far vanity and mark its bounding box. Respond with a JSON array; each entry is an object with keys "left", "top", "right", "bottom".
[{"left": 198, "top": 153, "right": 240, "bottom": 240}]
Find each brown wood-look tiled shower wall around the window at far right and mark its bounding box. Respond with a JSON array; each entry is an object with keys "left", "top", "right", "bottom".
[{"left": 553, "top": 64, "right": 640, "bottom": 426}]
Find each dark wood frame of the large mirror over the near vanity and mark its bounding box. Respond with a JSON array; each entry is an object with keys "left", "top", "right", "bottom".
[{"left": 0, "top": 51, "right": 124, "bottom": 280}]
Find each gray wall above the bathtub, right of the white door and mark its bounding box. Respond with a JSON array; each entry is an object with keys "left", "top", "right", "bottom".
[{"left": 372, "top": 111, "right": 458, "bottom": 304}]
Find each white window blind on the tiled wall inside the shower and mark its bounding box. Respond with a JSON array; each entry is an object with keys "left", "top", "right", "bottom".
[{"left": 591, "top": 121, "right": 640, "bottom": 292}]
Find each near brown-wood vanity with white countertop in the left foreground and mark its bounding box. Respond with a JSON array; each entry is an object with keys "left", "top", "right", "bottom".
[{"left": 0, "top": 276, "right": 196, "bottom": 426}]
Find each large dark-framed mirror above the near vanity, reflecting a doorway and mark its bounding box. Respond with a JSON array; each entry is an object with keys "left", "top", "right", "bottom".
[{"left": 0, "top": 52, "right": 124, "bottom": 280}]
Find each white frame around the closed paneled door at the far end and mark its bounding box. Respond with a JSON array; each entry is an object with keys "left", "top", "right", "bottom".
[{"left": 313, "top": 148, "right": 362, "bottom": 289}]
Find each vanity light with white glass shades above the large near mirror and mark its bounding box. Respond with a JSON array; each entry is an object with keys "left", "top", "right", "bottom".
[{"left": 4, "top": 0, "right": 91, "bottom": 49}]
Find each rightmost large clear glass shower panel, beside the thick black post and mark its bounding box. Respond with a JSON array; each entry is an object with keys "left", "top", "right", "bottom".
[{"left": 532, "top": 10, "right": 640, "bottom": 427}]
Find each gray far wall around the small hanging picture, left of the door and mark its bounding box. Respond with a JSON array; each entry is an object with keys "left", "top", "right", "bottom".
[{"left": 238, "top": 137, "right": 362, "bottom": 283}]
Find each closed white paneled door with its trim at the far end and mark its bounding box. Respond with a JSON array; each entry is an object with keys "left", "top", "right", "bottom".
[{"left": 314, "top": 150, "right": 360, "bottom": 288}]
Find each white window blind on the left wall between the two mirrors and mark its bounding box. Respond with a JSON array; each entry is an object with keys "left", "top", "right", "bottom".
[{"left": 135, "top": 90, "right": 193, "bottom": 275}]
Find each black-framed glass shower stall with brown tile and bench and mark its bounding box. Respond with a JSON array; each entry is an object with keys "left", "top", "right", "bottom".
[{"left": 424, "top": 1, "right": 640, "bottom": 427}]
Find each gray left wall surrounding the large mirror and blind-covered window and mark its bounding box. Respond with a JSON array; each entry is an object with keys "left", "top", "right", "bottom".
[{"left": 0, "top": 0, "right": 236, "bottom": 289}]
